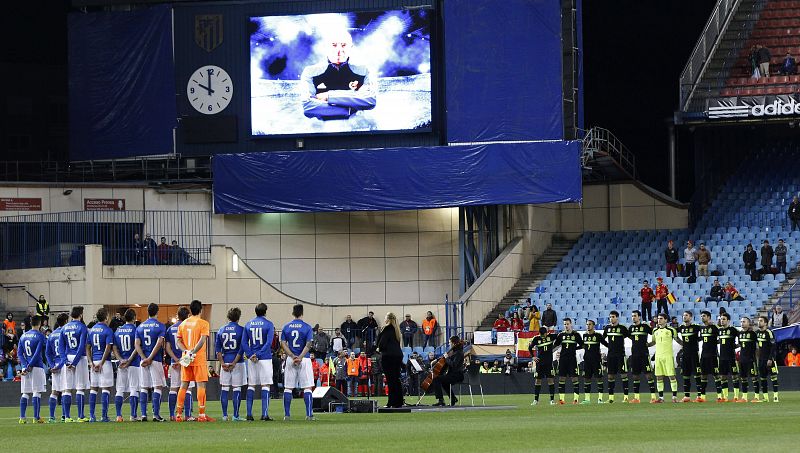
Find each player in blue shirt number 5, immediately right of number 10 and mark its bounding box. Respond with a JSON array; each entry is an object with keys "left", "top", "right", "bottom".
[{"left": 136, "top": 304, "right": 166, "bottom": 422}]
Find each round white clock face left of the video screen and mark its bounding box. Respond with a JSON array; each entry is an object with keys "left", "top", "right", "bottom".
[{"left": 186, "top": 65, "right": 233, "bottom": 115}]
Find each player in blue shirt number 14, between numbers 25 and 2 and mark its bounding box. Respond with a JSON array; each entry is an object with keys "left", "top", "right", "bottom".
[{"left": 242, "top": 303, "right": 275, "bottom": 421}]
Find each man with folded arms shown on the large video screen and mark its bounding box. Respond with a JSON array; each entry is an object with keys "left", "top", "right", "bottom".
[{"left": 300, "top": 30, "right": 376, "bottom": 120}]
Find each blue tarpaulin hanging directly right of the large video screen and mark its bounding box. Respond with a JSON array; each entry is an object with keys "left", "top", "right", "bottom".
[{"left": 443, "top": 0, "right": 564, "bottom": 143}]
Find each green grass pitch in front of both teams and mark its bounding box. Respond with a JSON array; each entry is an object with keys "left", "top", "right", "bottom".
[{"left": 0, "top": 392, "right": 800, "bottom": 453}]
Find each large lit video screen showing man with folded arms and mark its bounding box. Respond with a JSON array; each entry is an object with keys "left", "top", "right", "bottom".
[{"left": 250, "top": 9, "right": 433, "bottom": 136}]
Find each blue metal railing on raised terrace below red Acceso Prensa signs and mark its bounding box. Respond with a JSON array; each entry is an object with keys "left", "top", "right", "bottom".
[{"left": 0, "top": 211, "right": 211, "bottom": 269}]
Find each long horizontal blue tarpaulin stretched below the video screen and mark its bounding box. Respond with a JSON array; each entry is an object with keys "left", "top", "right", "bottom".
[{"left": 212, "top": 141, "right": 581, "bottom": 214}]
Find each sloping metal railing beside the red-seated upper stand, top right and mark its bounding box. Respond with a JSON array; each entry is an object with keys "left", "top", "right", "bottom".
[{"left": 679, "top": 0, "right": 740, "bottom": 111}]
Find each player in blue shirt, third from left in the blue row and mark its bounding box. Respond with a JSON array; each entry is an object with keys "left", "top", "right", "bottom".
[{"left": 61, "top": 306, "right": 89, "bottom": 423}]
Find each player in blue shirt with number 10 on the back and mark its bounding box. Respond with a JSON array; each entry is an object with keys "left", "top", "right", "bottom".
[{"left": 114, "top": 308, "right": 141, "bottom": 422}]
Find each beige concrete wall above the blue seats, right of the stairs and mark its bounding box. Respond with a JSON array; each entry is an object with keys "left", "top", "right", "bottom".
[{"left": 559, "top": 182, "right": 689, "bottom": 237}]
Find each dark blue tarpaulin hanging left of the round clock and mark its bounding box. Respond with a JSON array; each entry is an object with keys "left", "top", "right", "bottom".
[{"left": 68, "top": 5, "right": 177, "bottom": 160}]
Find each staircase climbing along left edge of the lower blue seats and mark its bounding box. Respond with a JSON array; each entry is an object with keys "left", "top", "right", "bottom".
[{"left": 477, "top": 238, "right": 578, "bottom": 330}]
